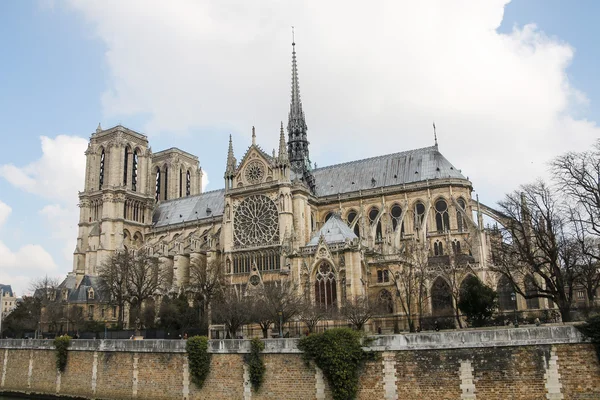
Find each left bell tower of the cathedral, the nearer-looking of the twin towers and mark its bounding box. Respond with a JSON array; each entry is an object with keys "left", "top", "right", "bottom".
[{"left": 73, "top": 124, "right": 154, "bottom": 282}]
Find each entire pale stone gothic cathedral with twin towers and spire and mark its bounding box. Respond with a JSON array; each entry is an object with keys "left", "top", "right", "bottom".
[{"left": 62, "top": 43, "right": 520, "bottom": 330}]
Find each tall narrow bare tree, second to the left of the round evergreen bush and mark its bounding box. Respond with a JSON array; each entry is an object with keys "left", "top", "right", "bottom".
[{"left": 390, "top": 241, "right": 429, "bottom": 332}]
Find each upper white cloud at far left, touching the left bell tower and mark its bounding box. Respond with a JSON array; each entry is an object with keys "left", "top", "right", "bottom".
[{"left": 0, "top": 135, "right": 87, "bottom": 207}]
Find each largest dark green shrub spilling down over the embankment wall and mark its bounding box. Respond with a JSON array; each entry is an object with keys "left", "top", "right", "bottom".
[{"left": 298, "top": 328, "right": 368, "bottom": 400}]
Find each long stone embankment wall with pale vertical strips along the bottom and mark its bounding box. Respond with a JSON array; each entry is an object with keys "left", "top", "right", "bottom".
[{"left": 0, "top": 326, "right": 600, "bottom": 400}]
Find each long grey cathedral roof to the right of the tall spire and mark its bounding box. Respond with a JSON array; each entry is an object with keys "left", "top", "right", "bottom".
[{"left": 312, "top": 146, "right": 466, "bottom": 196}]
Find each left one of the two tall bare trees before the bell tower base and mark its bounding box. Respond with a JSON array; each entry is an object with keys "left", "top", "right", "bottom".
[{"left": 98, "top": 250, "right": 134, "bottom": 326}]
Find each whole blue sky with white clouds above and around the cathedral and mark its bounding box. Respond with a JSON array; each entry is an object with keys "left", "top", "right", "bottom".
[{"left": 0, "top": 0, "right": 600, "bottom": 295}]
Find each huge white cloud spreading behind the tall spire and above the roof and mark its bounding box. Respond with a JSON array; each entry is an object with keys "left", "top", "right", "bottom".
[{"left": 65, "top": 0, "right": 600, "bottom": 202}]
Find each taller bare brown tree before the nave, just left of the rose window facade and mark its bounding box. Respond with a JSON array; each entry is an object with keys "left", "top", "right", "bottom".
[{"left": 190, "top": 257, "right": 225, "bottom": 325}]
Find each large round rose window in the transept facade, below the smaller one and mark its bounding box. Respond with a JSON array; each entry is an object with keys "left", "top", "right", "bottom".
[{"left": 233, "top": 195, "right": 279, "bottom": 246}]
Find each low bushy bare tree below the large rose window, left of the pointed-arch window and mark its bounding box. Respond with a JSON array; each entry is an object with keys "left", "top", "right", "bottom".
[{"left": 253, "top": 280, "right": 302, "bottom": 338}]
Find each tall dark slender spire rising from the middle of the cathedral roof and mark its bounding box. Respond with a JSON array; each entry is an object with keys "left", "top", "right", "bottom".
[{"left": 288, "top": 27, "right": 310, "bottom": 172}]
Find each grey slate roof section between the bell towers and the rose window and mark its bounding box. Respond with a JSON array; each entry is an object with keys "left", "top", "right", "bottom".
[{"left": 152, "top": 189, "right": 225, "bottom": 228}]
